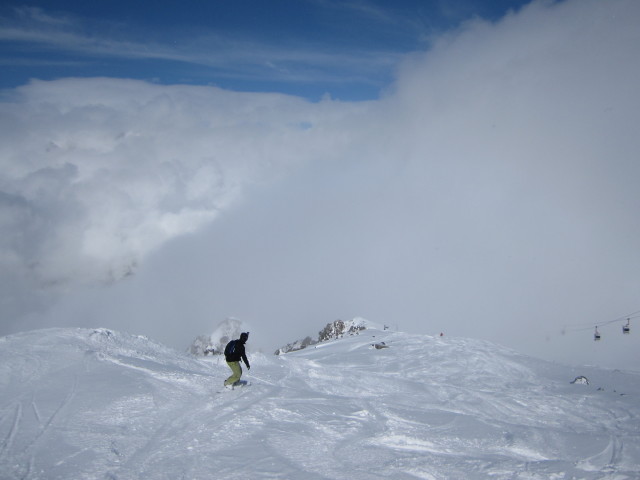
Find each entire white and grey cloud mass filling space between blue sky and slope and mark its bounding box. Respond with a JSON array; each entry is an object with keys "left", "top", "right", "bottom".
[{"left": 0, "top": 0, "right": 640, "bottom": 370}]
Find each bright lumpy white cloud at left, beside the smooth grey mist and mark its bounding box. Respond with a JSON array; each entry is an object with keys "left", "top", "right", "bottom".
[{"left": 0, "top": 79, "right": 340, "bottom": 290}]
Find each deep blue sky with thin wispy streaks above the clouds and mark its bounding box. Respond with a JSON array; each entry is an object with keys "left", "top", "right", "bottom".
[{"left": 0, "top": 0, "right": 525, "bottom": 100}]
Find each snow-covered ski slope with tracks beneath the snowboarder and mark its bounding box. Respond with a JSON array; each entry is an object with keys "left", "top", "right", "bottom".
[{"left": 0, "top": 329, "right": 640, "bottom": 480}]
